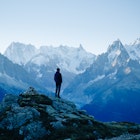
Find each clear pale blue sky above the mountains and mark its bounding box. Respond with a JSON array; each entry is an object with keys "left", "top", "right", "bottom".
[{"left": 0, "top": 0, "right": 140, "bottom": 55}]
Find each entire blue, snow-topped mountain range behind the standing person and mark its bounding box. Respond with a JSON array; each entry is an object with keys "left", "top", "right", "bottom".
[{"left": 0, "top": 39, "right": 140, "bottom": 122}]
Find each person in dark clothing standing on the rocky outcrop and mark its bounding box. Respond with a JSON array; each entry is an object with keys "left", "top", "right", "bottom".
[{"left": 54, "top": 68, "right": 62, "bottom": 98}]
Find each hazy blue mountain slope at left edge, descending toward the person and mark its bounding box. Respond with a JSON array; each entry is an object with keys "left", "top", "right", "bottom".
[{"left": 0, "top": 54, "right": 47, "bottom": 94}]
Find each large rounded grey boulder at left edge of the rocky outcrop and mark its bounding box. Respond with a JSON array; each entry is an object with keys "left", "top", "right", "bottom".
[{"left": 0, "top": 106, "right": 40, "bottom": 130}]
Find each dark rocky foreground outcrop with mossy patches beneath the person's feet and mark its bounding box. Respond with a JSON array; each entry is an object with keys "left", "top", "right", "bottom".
[{"left": 0, "top": 87, "right": 140, "bottom": 140}]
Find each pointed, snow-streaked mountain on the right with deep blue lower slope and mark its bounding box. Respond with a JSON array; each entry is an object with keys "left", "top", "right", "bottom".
[{"left": 64, "top": 40, "right": 140, "bottom": 123}]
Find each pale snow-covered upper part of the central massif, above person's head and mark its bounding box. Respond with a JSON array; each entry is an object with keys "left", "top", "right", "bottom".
[{"left": 4, "top": 42, "right": 95, "bottom": 74}]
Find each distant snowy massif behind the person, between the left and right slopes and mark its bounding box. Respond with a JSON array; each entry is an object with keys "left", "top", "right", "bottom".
[{"left": 4, "top": 42, "right": 95, "bottom": 91}]
